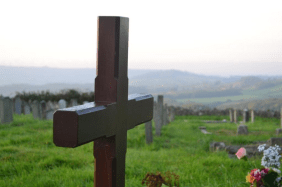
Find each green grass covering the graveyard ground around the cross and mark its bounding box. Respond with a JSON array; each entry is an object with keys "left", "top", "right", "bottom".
[{"left": 0, "top": 114, "right": 280, "bottom": 187}]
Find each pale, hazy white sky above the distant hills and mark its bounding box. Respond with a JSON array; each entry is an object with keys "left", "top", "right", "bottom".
[{"left": 0, "top": 0, "right": 282, "bottom": 77}]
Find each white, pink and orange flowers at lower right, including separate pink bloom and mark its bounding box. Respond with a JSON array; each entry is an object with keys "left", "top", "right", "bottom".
[{"left": 236, "top": 144, "right": 282, "bottom": 187}]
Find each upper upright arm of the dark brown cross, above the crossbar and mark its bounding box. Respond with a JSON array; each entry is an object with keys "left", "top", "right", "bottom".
[{"left": 95, "top": 16, "right": 129, "bottom": 105}]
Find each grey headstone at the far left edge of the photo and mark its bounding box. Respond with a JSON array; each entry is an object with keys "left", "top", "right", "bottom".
[{"left": 0, "top": 97, "right": 13, "bottom": 123}]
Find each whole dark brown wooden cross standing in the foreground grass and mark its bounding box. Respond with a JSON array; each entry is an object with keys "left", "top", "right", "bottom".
[{"left": 53, "top": 16, "right": 154, "bottom": 187}]
